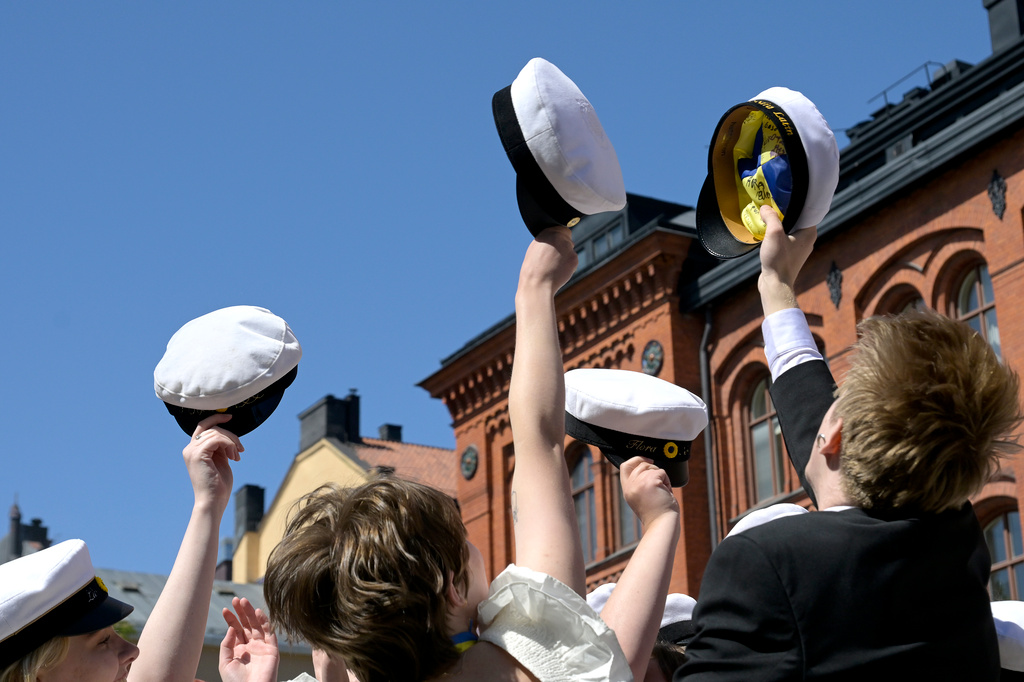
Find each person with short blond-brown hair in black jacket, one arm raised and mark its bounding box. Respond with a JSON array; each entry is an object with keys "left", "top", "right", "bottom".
[{"left": 675, "top": 207, "right": 1022, "bottom": 682}]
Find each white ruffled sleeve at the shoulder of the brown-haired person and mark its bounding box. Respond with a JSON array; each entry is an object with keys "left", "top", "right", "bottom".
[{"left": 478, "top": 564, "right": 633, "bottom": 682}]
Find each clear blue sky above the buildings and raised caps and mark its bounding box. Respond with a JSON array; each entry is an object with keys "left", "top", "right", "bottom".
[{"left": 0, "top": 0, "right": 991, "bottom": 573}]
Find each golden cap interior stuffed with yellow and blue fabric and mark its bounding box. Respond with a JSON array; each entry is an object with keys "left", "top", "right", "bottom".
[{"left": 732, "top": 110, "right": 793, "bottom": 242}]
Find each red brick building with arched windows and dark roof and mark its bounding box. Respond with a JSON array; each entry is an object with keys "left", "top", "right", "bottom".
[{"left": 421, "top": 0, "right": 1024, "bottom": 599}]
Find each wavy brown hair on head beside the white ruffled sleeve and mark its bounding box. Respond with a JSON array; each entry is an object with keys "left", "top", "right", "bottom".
[{"left": 263, "top": 477, "right": 469, "bottom": 682}]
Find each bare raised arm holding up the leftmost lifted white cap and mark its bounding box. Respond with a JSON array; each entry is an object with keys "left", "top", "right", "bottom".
[{"left": 128, "top": 415, "right": 237, "bottom": 682}]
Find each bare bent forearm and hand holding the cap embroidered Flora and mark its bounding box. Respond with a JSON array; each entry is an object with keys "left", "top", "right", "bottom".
[{"left": 601, "top": 457, "right": 679, "bottom": 680}]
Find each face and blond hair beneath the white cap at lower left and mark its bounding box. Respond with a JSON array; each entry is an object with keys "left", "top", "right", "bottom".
[{"left": 36, "top": 628, "right": 138, "bottom": 682}]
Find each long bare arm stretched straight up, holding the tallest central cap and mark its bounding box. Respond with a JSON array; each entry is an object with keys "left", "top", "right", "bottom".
[{"left": 509, "top": 227, "right": 586, "bottom": 596}]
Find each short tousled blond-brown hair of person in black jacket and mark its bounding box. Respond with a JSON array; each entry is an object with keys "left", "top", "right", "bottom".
[{"left": 836, "top": 311, "right": 1021, "bottom": 512}]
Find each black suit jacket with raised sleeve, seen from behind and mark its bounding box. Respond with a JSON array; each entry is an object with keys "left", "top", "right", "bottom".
[{"left": 674, "top": 360, "right": 999, "bottom": 682}]
